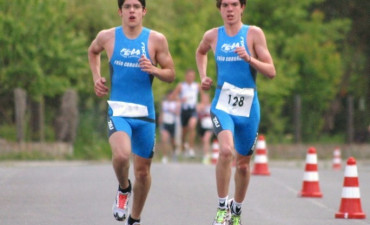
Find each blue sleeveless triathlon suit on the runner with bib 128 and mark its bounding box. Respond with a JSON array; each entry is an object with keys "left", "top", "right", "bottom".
[{"left": 211, "top": 25, "right": 260, "bottom": 156}]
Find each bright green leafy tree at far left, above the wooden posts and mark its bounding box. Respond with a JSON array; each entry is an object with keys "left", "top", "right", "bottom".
[{"left": 0, "top": 0, "right": 88, "bottom": 141}]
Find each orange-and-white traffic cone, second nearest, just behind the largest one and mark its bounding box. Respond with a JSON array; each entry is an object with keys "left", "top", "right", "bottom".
[{"left": 299, "top": 147, "right": 322, "bottom": 198}]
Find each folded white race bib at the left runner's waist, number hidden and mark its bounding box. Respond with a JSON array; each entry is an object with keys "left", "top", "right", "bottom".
[{"left": 108, "top": 100, "right": 149, "bottom": 117}]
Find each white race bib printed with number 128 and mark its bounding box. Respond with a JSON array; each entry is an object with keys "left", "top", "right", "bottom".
[{"left": 216, "top": 82, "right": 254, "bottom": 117}]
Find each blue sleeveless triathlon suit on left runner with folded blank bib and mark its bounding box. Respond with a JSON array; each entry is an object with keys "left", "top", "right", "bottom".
[{"left": 108, "top": 26, "right": 155, "bottom": 158}]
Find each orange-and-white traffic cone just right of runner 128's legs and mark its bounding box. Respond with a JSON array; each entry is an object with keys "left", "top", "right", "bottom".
[{"left": 252, "top": 135, "right": 270, "bottom": 175}]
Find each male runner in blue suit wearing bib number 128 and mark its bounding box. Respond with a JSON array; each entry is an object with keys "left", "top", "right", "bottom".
[{"left": 196, "top": 0, "right": 276, "bottom": 225}]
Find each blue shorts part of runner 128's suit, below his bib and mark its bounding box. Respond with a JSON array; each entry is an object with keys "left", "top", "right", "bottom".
[{"left": 211, "top": 101, "right": 260, "bottom": 156}]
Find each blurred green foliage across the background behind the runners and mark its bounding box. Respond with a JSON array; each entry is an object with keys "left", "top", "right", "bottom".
[{"left": 0, "top": 0, "right": 370, "bottom": 158}]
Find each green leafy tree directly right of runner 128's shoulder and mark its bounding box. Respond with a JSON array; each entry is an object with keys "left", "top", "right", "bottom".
[{"left": 246, "top": 0, "right": 350, "bottom": 140}]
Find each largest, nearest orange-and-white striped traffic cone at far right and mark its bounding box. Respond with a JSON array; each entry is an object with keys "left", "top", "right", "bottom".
[{"left": 335, "top": 157, "right": 366, "bottom": 219}]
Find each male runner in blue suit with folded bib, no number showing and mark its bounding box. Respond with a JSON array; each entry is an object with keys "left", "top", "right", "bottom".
[{"left": 88, "top": 0, "right": 175, "bottom": 225}]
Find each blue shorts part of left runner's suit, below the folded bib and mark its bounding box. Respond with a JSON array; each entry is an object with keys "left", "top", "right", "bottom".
[{"left": 108, "top": 116, "right": 155, "bottom": 158}]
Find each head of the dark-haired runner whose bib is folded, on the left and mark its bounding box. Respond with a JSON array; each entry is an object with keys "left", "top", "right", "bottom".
[{"left": 118, "top": 0, "right": 146, "bottom": 27}]
